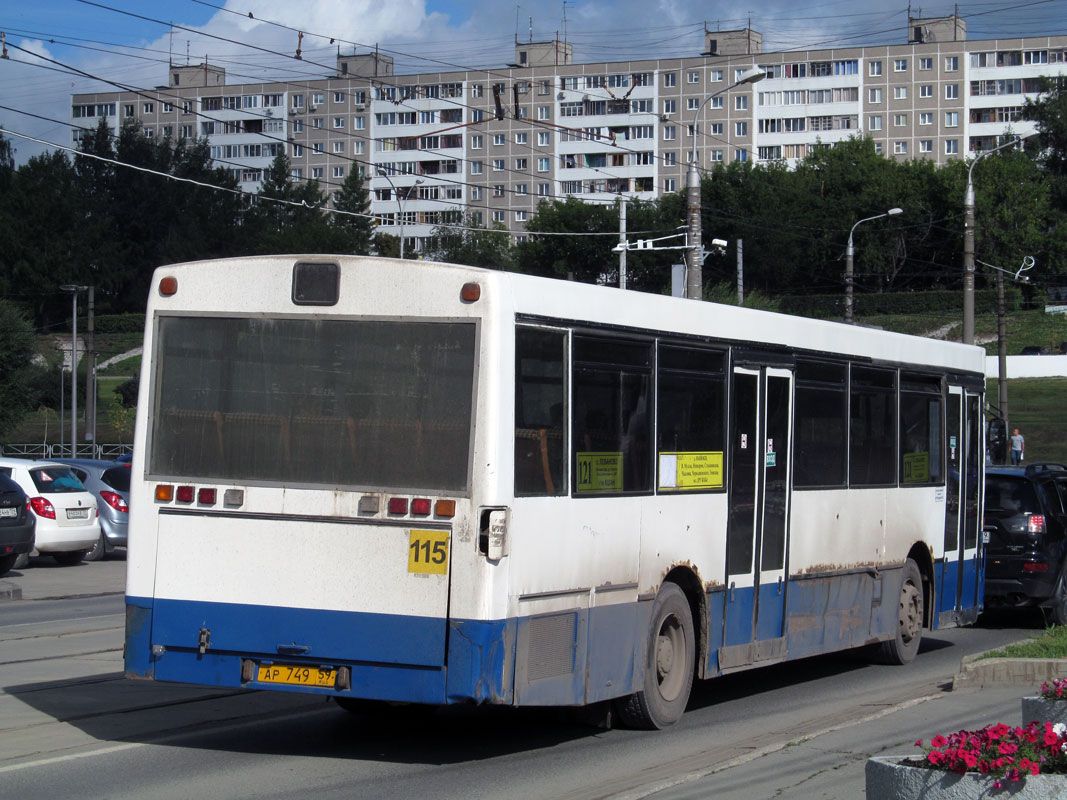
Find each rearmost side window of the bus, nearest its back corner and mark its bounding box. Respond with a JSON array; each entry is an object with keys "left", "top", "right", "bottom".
[{"left": 515, "top": 327, "right": 567, "bottom": 497}]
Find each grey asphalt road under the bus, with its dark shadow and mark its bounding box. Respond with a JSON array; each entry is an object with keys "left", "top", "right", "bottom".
[{"left": 0, "top": 561, "right": 1040, "bottom": 800}]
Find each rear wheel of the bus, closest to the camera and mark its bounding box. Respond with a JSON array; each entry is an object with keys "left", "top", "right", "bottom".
[{"left": 618, "top": 583, "right": 697, "bottom": 731}]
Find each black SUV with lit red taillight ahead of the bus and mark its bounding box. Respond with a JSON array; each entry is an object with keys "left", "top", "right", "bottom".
[{"left": 984, "top": 463, "right": 1067, "bottom": 625}]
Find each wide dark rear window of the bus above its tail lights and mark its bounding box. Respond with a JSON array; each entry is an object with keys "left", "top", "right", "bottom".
[{"left": 148, "top": 317, "right": 476, "bottom": 492}]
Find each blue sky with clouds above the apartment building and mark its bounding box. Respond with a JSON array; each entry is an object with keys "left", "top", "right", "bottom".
[{"left": 0, "top": 0, "right": 1067, "bottom": 163}]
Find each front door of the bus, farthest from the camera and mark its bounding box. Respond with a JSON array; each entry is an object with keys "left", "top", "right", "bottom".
[{"left": 938, "top": 386, "right": 983, "bottom": 624}]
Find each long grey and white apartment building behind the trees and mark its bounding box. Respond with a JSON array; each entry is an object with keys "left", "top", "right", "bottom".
[{"left": 73, "top": 17, "right": 1067, "bottom": 252}]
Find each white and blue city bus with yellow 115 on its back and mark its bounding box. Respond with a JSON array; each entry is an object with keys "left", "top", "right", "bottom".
[{"left": 126, "top": 256, "right": 985, "bottom": 727}]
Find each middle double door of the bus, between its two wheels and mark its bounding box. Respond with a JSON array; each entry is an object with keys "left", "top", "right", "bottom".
[{"left": 719, "top": 366, "right": 793, "bottom": 671}]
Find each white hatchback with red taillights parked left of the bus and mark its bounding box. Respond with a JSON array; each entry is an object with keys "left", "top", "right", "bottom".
[{"left": 0, "top": 459, "right": 100, "bottom": 564}]
